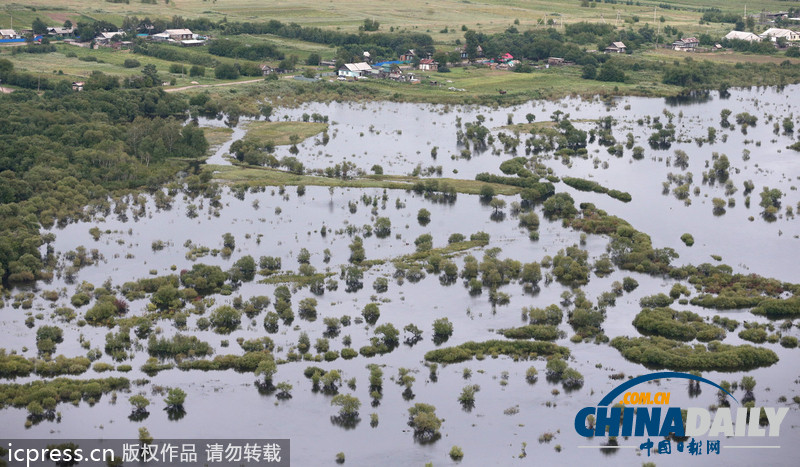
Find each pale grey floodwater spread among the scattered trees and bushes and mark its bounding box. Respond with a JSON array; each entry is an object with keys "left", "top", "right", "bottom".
[{"left": 0, "top": 86, "right": 800, "bottom": 465}]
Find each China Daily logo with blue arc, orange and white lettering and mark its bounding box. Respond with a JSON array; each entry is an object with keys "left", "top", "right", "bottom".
[{"left": 575, "top": 371, "right": 789, "bottom": 455}]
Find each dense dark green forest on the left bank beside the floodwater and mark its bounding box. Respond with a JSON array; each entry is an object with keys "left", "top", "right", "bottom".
[{"left": 0, "top": 60, "right": 208, "bottom": 282}]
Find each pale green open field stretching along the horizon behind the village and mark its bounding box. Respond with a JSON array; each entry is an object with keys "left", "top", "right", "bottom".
[{"left": 6, "top": 0, "right": 791, "bottom": 42}]
